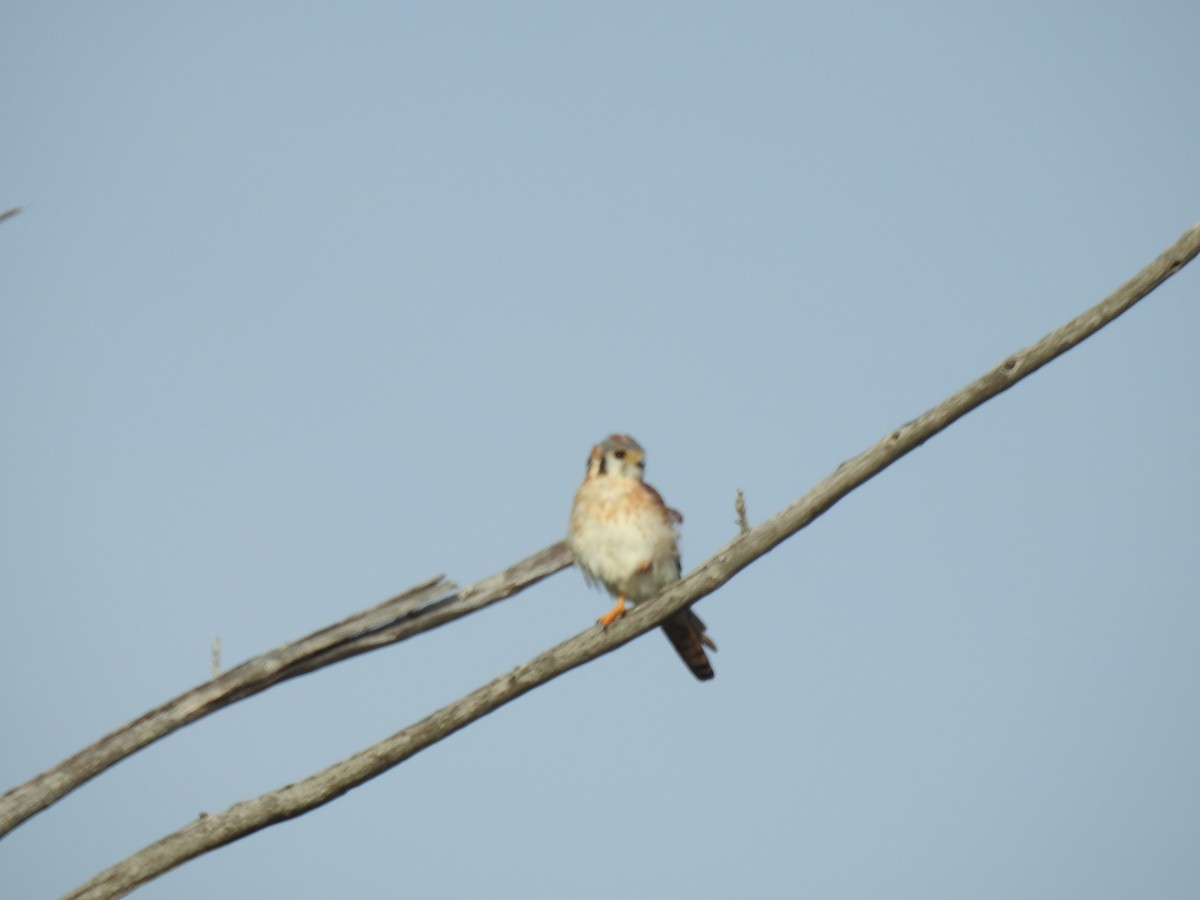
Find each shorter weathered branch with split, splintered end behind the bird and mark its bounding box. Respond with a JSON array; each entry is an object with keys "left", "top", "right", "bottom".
[{"left": 0, "top": 541, "right": 571, "bottom": 838}]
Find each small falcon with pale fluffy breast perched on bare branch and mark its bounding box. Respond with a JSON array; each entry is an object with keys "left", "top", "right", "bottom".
[{"left": 566, "top": 434, "right": 716, "bottom": 682}]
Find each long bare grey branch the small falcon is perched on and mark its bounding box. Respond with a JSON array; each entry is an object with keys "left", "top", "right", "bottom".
[{"left": 68, "top": 220, "right": 1200, "bottom": 900}]
